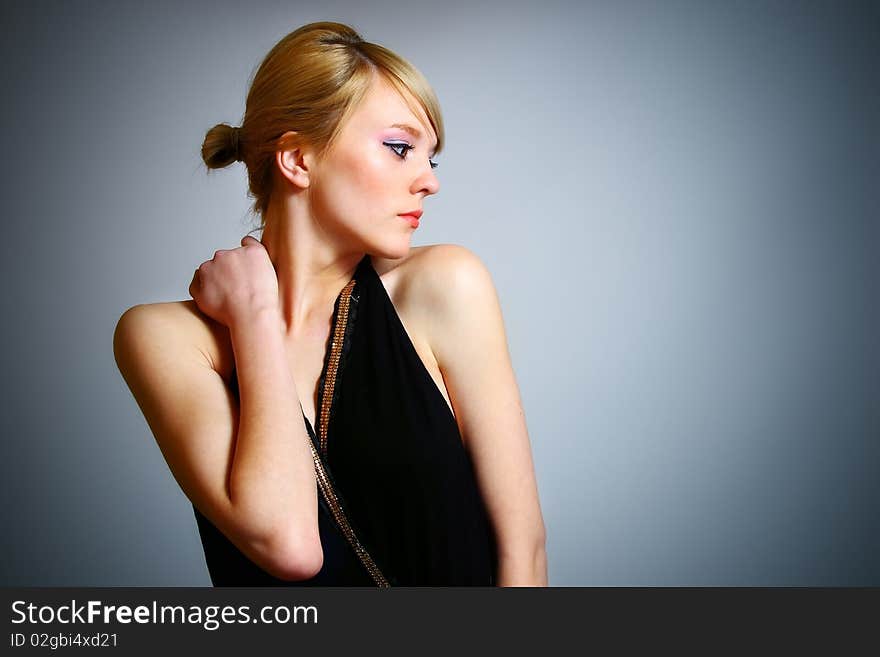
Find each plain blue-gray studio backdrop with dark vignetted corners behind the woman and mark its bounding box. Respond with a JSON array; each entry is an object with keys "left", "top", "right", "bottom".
[{"left": 0, "top": 0, "right": 880, "bottom": 586}]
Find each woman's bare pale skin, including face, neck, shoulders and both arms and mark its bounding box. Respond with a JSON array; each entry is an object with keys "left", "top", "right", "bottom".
[{"left": 114, "top": 77, "right": 547, "bottom": 586}]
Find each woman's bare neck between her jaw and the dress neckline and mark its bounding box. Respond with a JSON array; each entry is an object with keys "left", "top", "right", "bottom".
[{"left": 261, "top": 196, "right": 364, "bottom": 338}]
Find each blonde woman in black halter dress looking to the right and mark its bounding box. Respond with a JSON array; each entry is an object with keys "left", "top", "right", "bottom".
[{"left": 114, "top": 22, "right": 547, "bottom": 586}]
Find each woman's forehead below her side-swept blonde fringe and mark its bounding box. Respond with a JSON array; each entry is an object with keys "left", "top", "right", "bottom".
[{"left": 346, "top": 75, "right": 437, "bottom": 147}]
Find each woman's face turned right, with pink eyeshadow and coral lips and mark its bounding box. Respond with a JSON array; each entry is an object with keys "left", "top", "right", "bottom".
[{"left": 308, "top": 76, "right": 440, "bottom": 258}]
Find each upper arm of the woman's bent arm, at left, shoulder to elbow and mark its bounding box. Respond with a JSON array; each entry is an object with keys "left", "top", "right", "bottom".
[{"left": 113, "top": 304, "right": 310, "bottom": 578}]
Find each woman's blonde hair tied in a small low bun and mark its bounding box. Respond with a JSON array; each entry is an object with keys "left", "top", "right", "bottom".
[{"left": 202, "top": 21, "right": 443, "bottom": 228}]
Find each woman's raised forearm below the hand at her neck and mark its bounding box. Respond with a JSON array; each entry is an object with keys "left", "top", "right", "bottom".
[{"left": 229, "top": 311, "right": 317, "bottom": 545}]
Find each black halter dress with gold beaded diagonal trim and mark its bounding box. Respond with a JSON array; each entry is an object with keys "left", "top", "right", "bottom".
[{"left": 193, "top": 255, "right": 496, "bottom": 586}]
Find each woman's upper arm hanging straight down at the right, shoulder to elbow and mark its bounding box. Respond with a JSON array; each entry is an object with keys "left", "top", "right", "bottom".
[{"left": 422, "top": 245, "right": 544, "bottom": 552}]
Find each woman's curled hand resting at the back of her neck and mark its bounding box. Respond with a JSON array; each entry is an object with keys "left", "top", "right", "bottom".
[{"left": 189, "top": 235, "right": 280, "bottom": 328}]
